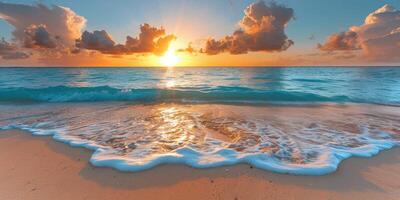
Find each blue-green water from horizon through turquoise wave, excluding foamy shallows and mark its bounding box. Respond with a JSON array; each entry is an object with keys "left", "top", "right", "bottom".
[{"left": 0, "top": 67, "right": 400, "bottom": 105}]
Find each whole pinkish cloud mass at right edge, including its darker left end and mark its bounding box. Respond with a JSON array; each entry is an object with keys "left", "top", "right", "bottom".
[{"left": 318, "top": 5, "right": 400, "bottom": 61}]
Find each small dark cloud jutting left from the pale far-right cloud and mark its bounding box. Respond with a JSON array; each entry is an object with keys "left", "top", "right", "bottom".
[{"left": 318, "top": 31, "right": 360, "bottom": 51}]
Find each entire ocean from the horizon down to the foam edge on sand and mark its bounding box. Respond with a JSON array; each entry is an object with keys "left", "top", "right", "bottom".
[{"left": 0, "top": 67, "right": 400, "bottom": 175}]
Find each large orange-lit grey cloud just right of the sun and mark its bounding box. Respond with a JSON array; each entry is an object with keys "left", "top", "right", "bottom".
[{"left": 201, "top": 1, "right": 294, "bottom": 55}]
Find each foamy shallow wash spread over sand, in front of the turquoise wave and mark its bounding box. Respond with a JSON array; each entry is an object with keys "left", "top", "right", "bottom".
[{"left": 0, "top": 103, "right": 400, "bottom": 174}]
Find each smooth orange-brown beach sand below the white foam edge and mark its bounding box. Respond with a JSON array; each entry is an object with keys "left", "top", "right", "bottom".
[{"left": 0, "top": 130, "right": 400, "bottom": 200}]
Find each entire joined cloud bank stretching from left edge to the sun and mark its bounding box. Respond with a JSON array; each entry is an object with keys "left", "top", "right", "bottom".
[{"left": 0, "top": 2, "right": 176, "bottom": 64}]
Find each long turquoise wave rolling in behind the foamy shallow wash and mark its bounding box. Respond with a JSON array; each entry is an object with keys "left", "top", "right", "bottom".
[{"left": 0, "top": 86, "right": 356, "bottom": 103}]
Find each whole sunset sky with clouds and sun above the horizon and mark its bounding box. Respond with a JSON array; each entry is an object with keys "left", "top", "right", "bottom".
[{"left": 0, "top": 0, "right": 400, "bottom": 66}]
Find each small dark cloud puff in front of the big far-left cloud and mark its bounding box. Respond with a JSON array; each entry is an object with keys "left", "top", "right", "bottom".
[{"left": 24, "top": 25, "right": 57, "bottom": 48}]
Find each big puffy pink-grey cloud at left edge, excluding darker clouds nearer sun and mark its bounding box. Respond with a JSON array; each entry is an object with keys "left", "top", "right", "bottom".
[{"left": 0, "top": 2, "right": 86, "bottom": 62}]
